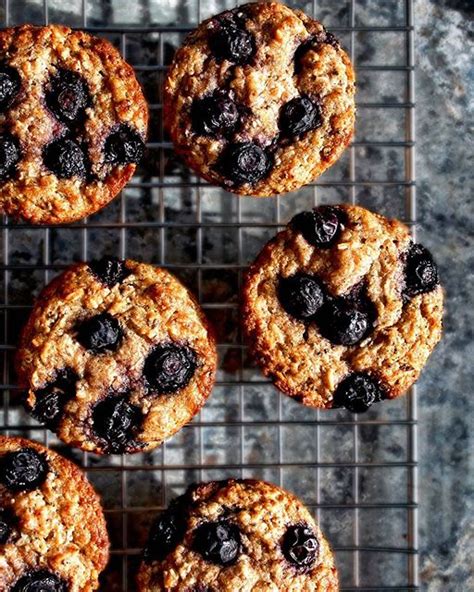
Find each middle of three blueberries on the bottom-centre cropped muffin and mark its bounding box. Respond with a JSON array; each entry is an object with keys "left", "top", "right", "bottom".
[{"left": 193, "top": 520, "right": 242, "bottom": 566}]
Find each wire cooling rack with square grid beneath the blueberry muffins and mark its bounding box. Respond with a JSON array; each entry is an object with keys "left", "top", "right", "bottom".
[{"left": 0, "top": 0, "right": 418, "bottom": 591}]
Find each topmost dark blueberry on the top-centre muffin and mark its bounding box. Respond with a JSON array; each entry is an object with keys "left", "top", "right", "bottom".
[{"left": 209, "top": 18, "right": 256, "bottom": 65}]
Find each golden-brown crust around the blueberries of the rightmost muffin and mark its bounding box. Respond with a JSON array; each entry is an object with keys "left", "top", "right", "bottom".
[{"left": 241, "top": 205, "right": 443, "bottom": 409}]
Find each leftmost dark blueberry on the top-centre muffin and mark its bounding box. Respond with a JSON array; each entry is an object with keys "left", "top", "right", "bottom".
[{"left": 191, "top": 93, "right": 240, "bottom": 136}]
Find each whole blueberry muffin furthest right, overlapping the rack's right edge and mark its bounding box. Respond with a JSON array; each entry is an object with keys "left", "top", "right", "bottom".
[{"left": 243, "top": 205, "right": 443, "bottom": 412}]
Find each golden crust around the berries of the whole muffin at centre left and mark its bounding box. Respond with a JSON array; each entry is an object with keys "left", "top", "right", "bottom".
[{"left": 16, "top": 260, "right": 217, "bottom": 454}]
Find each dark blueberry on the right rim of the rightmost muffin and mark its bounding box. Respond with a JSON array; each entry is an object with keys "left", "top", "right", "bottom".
[{"left": 405, "top": 243, "right": 439, "bottom": 296}]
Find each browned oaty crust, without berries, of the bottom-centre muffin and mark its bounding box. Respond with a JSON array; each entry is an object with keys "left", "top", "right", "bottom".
[{"left": 137, "top": 479, "right": 339, "bottom": 592}]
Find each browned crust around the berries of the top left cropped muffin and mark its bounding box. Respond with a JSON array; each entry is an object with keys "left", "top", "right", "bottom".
[{"left": 0, "top": 25, "right": 148, "bottom": 224}]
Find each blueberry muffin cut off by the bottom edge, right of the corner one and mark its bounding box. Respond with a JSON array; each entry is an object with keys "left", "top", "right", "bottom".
[{"left": 137, "top": 479, "right": 339, "bottom": 592}]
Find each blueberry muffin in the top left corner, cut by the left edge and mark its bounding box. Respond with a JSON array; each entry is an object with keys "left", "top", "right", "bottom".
[{"left": 0, "top": 25, "right": 148, "bottom": 224}]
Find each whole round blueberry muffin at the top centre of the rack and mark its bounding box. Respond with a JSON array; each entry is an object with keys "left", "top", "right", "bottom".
[{"left": 164, "top": 2, "right": 355, "bottom": 197}]
